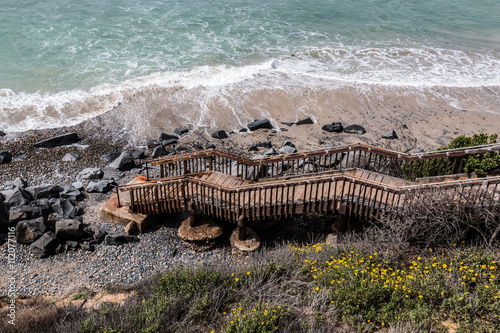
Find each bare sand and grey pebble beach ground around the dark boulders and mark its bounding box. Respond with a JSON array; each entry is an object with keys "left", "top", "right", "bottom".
[{"left": 0, "top": 103, "right": 500, "bottom": 297}]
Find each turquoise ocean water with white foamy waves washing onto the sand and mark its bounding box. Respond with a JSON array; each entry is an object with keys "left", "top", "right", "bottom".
[{"left": 0, "top": 0, "right": 500, "bottom": 131}]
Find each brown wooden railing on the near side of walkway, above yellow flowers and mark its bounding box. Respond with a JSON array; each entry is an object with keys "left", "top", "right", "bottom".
[{"left": 120, "top": 172, "right": 500, "bottom": 223}]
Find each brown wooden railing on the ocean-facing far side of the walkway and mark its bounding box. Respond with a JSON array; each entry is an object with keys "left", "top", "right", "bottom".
[{"left": 150, "top": 144, "right": 500, "bottom": 181}]
